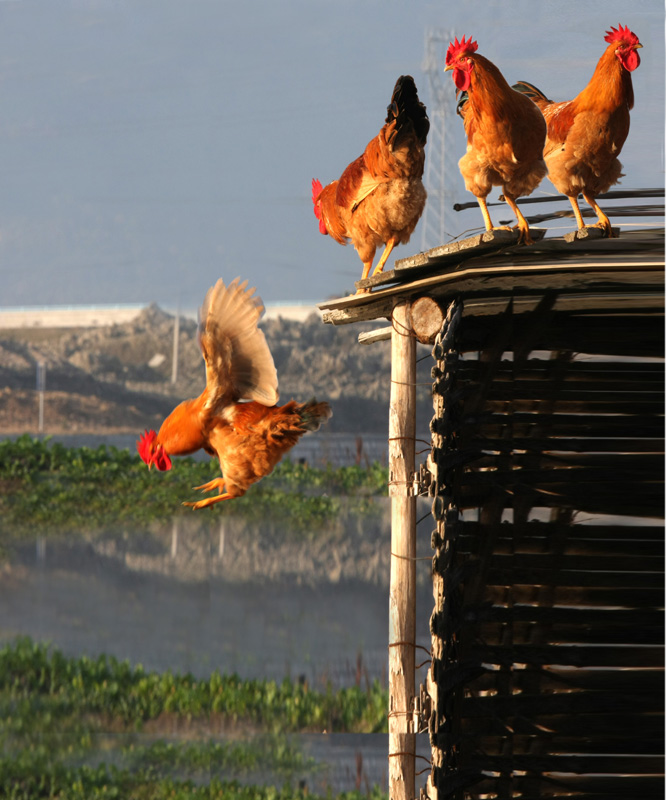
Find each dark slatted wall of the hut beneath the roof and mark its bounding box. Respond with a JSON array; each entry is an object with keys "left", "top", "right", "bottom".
[{"left": 425, "top": 294, "right": 664, "bottom": 800}]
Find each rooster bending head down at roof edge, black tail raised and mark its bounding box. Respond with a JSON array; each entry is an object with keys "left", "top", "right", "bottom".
[{"left": 312, "top": 75, "right": 430, "bottom": 292}]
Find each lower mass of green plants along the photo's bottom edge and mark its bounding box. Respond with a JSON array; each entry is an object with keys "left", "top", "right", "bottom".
[{"left": 0, "top": 638, "right": 388, "bottom": 800}]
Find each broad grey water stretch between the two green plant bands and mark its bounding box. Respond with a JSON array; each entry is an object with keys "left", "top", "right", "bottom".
[{"left": 0, "top": 523, "right": 432, "bottom": 688}]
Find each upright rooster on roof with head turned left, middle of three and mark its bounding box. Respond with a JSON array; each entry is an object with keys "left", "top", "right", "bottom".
[{"left": 444, "top": 36, "right": 547, "bottom": 244}]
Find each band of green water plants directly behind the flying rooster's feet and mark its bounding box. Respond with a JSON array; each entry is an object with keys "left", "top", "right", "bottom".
[{"left": 0, "top": 435, "right": 387, "bottom": 533}]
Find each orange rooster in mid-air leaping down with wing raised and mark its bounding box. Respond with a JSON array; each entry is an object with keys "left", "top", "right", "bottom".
[{"left": 136, "top": 278, "right": 331, "bottom": 508}]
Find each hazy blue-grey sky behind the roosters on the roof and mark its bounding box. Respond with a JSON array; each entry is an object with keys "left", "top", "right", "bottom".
[{"left": 0, "top": 0, "right": 664, "bottom": 310}]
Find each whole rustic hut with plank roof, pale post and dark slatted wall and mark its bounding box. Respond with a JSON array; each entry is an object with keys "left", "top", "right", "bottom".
[{"left": 320, "top": 223, "right": 664, "bottom": 800}]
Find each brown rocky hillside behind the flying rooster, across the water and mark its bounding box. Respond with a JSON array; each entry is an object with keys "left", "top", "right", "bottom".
[{"left": 0, "top": 305, "right": 432, "bottom": 433}]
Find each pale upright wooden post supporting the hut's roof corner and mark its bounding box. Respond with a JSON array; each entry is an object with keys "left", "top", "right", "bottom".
[{"left": 388, "top": 302, "right": 416, "bottom": 800}]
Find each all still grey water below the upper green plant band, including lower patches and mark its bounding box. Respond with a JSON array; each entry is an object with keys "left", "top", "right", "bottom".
[{"left": 0, "top": 500, "right": 432, "bottom": 795}]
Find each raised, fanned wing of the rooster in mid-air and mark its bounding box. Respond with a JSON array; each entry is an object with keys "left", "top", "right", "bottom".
[{"left": 199, "top": 278, "right": 278, "bottom": 406}]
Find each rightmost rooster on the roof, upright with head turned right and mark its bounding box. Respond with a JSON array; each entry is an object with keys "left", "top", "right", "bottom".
[{"left": 514, "top": 25, "right": 643, "bottom": 236}]
